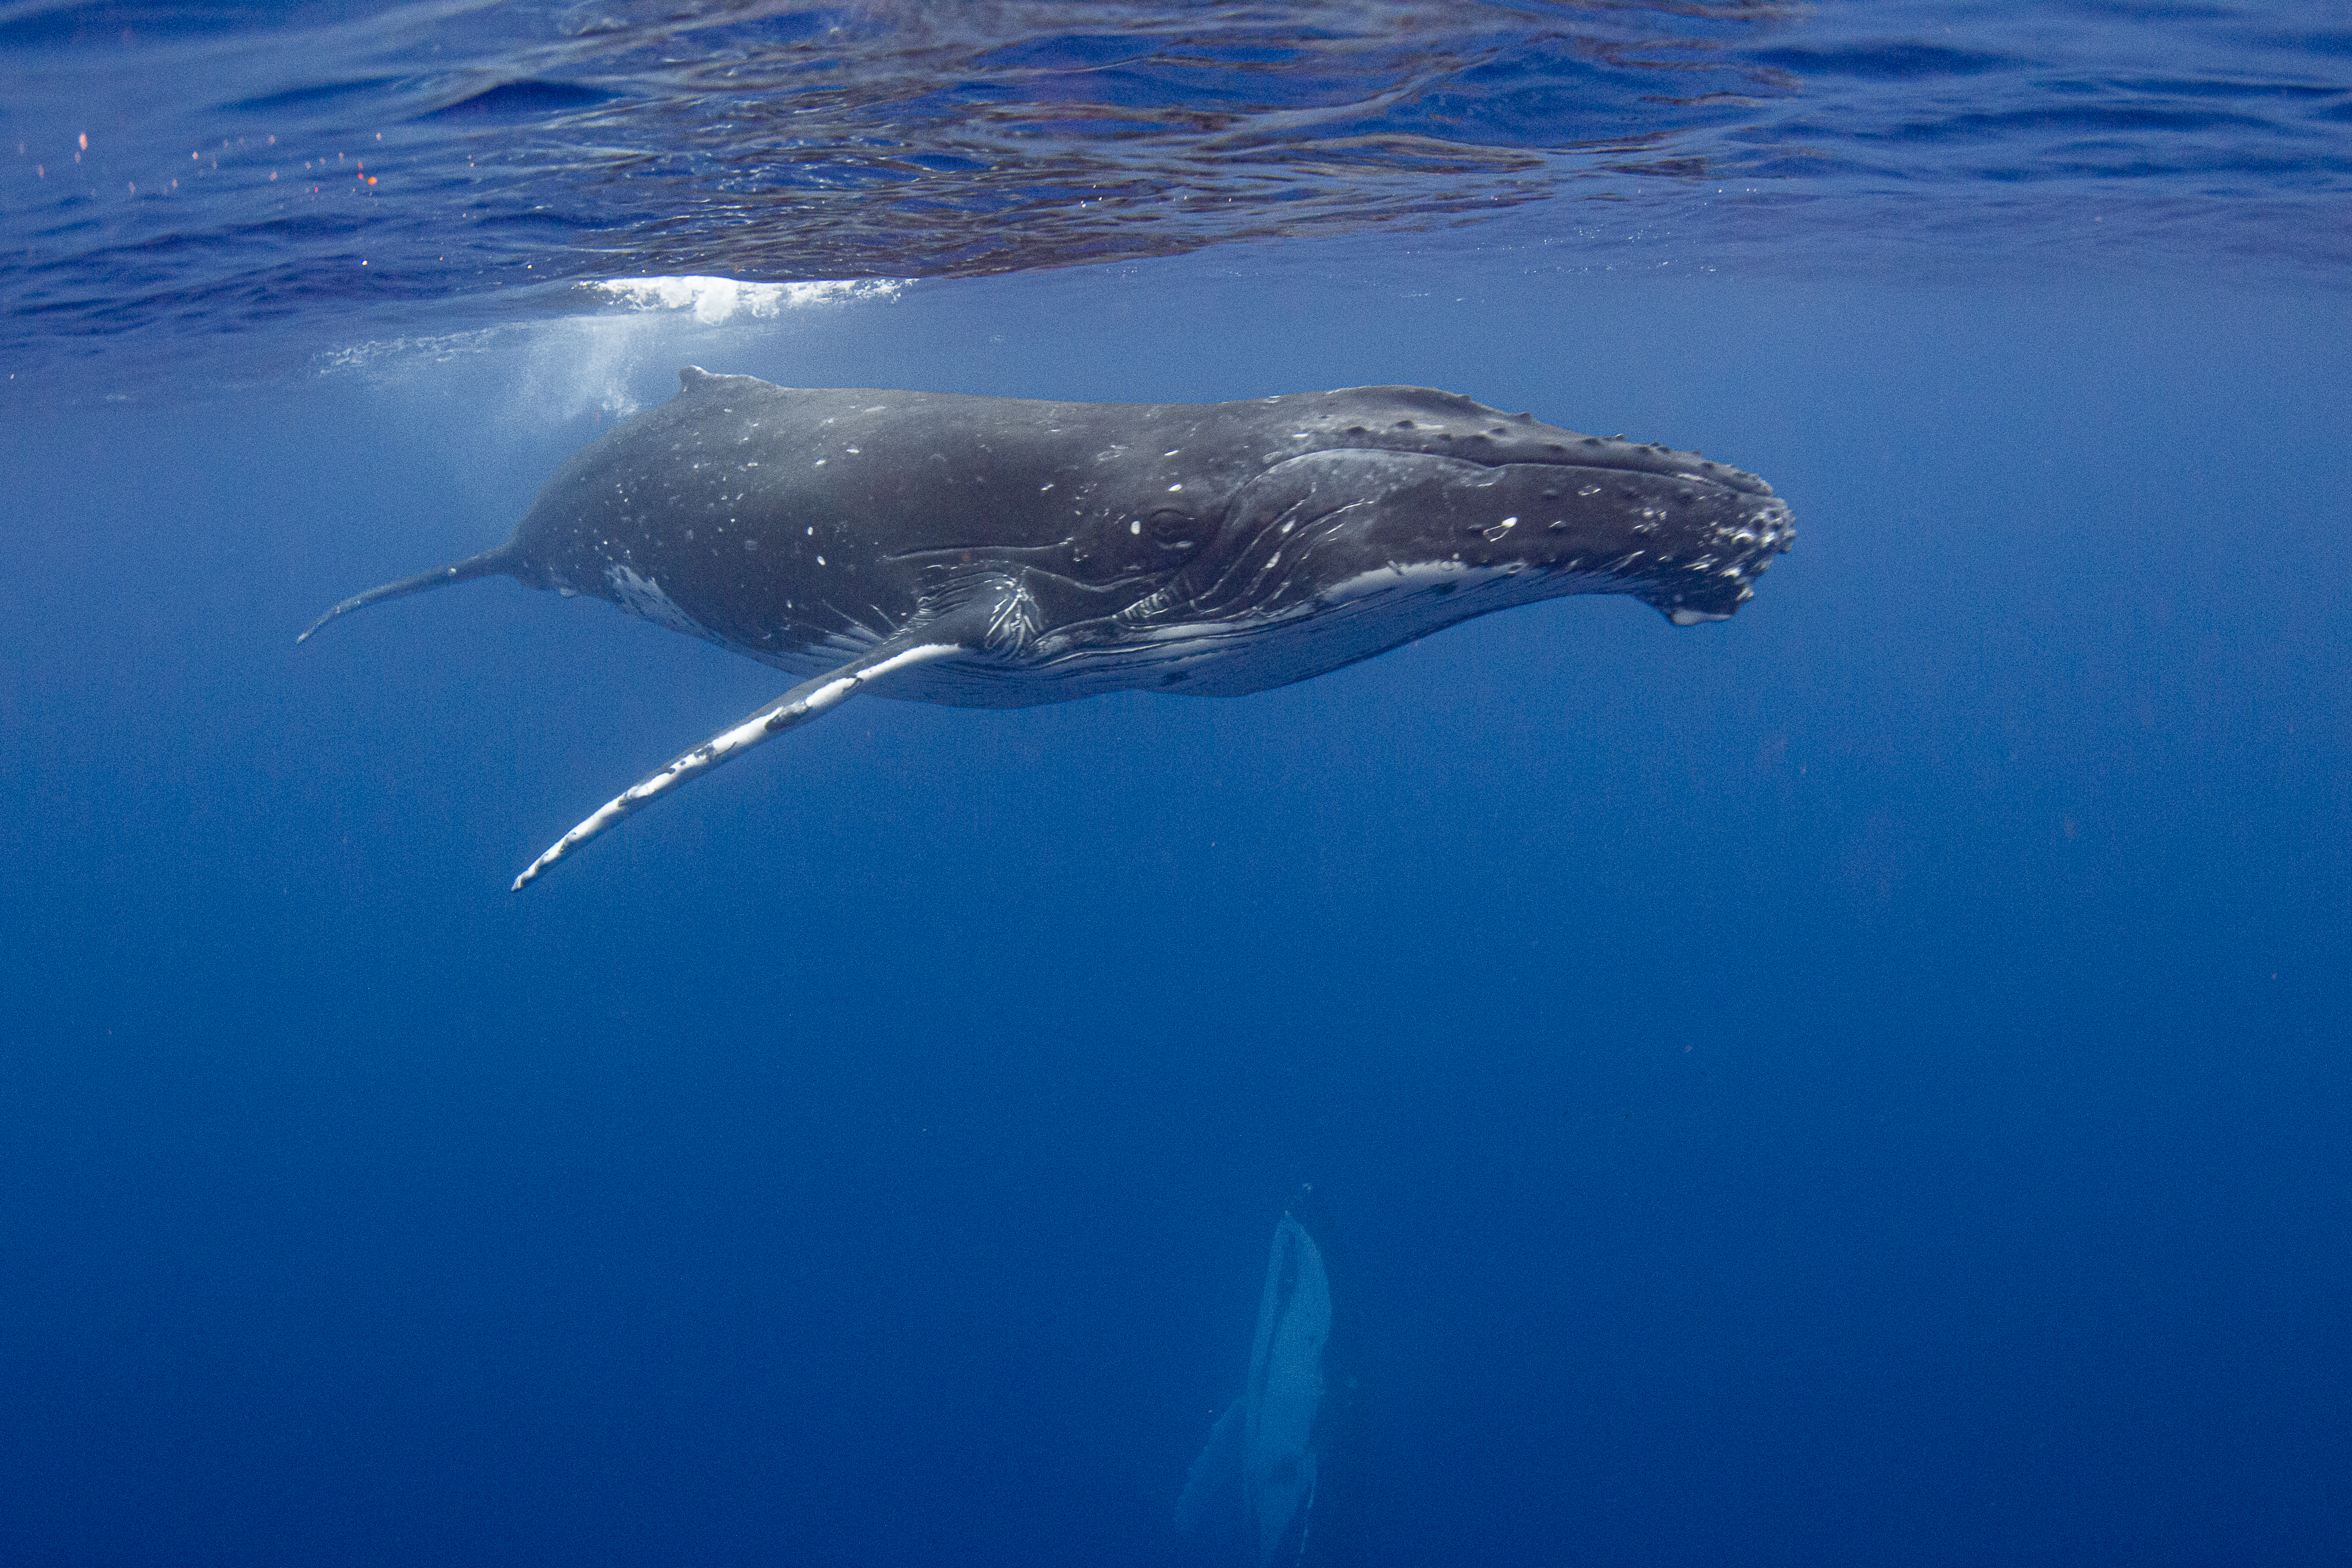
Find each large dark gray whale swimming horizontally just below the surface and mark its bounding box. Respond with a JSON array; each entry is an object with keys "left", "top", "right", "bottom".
[{"left": 303, "top": 369, "right": 1795, "bottom": 888}]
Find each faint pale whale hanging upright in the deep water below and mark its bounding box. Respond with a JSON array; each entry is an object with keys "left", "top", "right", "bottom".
[{"left": 1176, "top": 1189, "right": 1336, "bottom": 1568}]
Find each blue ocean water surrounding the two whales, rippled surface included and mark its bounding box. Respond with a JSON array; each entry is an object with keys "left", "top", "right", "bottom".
[{"left": 0, "top": 0, "right": 2352, "bottom": 1568}]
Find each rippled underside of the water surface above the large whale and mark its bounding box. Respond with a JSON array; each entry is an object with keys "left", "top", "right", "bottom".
[{"left": 0, "top": 0, "right": 2352, "bottom": 371}]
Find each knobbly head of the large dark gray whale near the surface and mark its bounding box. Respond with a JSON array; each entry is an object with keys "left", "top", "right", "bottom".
[{"left": 1077, "top": 386, "right": 1795, "bottom": 691}]
